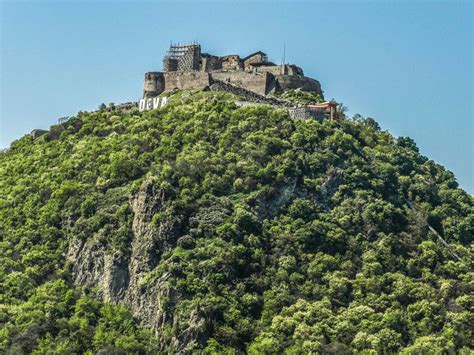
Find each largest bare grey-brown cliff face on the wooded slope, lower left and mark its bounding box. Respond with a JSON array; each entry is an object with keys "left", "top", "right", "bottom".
[{"left": 67, "top": 180, "right": 183, "bottom": 350}]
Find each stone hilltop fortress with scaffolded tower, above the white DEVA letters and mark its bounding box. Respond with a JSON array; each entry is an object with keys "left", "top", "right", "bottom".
[{"left": 143, "top": 43, "right": 322, "bottom": 99}]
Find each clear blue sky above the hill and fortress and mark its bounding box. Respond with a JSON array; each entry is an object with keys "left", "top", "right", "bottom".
[{"left": 0, "top": 0, "right": 474, "bottom": 194}]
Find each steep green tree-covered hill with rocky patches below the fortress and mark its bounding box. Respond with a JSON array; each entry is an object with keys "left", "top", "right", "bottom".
[{"left": 0, "top": 92, "right": 474, "bottom": 354}]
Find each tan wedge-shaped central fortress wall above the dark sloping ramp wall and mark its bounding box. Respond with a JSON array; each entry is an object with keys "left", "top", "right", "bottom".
[{"left": 212, "top": 71, "right": 273, "bottom": 95}]
